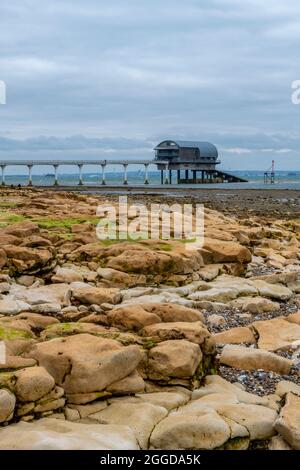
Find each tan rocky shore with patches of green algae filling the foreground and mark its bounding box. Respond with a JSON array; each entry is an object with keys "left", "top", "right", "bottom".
[{"left": 0, "top": 188, "right": 300, "bottom": 450}]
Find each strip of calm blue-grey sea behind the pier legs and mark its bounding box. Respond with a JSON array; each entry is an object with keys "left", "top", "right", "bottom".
[{"left": 5, "top": 170, "right": 300, "bottom": 189}]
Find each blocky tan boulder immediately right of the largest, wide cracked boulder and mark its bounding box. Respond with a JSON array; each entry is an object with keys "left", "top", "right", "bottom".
[{"left": 148, "top": 340, "right": 202, "bottom": 380}]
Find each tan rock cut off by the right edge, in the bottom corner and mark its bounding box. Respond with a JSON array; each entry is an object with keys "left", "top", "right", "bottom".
[{"left": 275, "top": 392, "right": 300, "bottom": 450}]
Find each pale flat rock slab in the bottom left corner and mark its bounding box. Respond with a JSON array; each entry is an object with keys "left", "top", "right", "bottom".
[{"left": 0, "top": 418, "right": 139, "bottom": 451}]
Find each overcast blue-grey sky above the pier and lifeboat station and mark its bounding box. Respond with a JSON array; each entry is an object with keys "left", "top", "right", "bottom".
[{"left": 0, "top": 0, "right": 300, "bottom": 170}]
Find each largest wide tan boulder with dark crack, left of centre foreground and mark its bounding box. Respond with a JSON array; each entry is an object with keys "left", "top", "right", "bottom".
[{"left": 27, "top": 334, "right": 142, "bottom": 394}]
